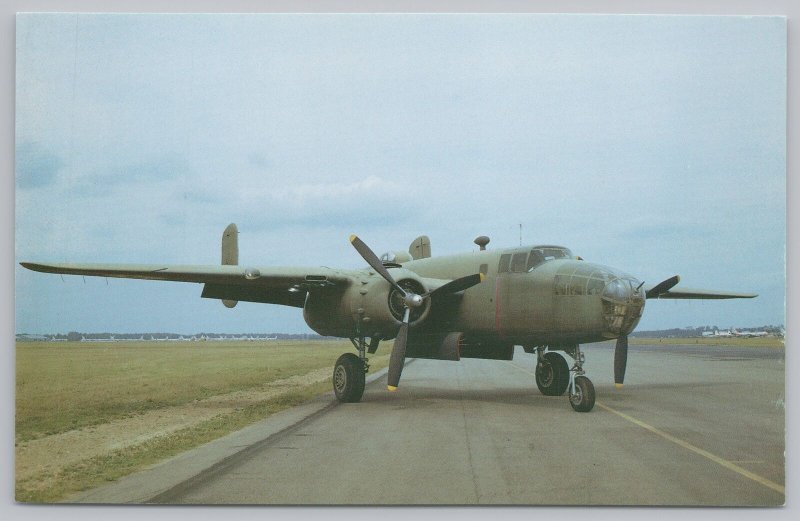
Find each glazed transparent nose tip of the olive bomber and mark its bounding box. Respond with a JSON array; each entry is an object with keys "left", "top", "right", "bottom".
[{"left": 601, "top": 276, "right": 645, "bottom": 338}]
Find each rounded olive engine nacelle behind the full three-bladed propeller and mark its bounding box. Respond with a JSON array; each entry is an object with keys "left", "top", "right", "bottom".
[{"left": 303, "top": 268, "right": 431, "bottom": 340}]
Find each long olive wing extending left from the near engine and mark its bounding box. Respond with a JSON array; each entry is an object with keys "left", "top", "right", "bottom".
[{"left": 20, "top": 262, "right": 354, "bottom": 307}]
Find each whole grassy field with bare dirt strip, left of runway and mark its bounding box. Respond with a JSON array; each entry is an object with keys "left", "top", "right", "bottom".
[{"left": 16, "top": 341, "right": 389, "bottom": 502}]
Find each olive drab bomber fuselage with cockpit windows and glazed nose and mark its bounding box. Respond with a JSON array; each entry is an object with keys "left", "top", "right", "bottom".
[{"left": 403, "top": 248, "right": 645, "bottom": 345}]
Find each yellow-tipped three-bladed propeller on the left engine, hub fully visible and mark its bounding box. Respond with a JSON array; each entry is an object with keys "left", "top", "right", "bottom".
[{"left": 350, "top": 235, "right": 484, "bottom": 391}]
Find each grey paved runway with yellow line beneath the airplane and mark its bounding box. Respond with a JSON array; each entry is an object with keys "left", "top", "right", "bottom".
[{"left": 72, "top": 344, "right": 785, "bottom": 506}]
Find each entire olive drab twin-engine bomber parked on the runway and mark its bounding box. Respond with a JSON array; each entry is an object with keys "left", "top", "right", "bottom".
[{"left": 21, "top": 224, "right": 756, "bottom": 412}]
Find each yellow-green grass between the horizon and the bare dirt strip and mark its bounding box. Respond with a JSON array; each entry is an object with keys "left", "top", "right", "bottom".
[{"left": 16, "top": 341, "right": 352, "bottom": 441}]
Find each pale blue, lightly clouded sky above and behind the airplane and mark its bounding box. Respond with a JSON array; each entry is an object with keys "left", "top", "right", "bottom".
[{"left": 15, "top": 14, "right": 786, "bottom": 333}]
